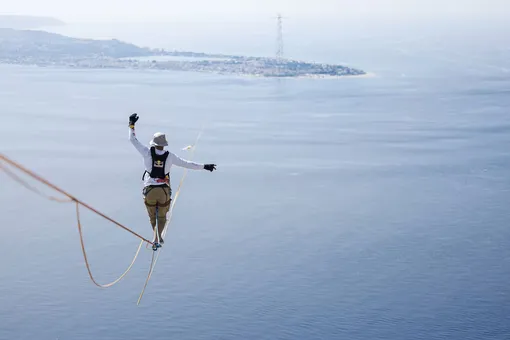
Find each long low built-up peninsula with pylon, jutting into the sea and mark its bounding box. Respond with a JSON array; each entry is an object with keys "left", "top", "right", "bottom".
[{"left": 0, "top": 28, "right": 365, "bottom": 77}]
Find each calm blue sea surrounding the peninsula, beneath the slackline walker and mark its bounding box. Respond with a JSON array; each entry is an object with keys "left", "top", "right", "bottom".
[{"left": 0, "top": 19, "right": 510, "bottom": 340}]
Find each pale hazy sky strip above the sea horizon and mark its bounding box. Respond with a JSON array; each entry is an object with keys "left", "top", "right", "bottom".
[{"left": 0, "top": 0, "right": 510, "bottom": 21}]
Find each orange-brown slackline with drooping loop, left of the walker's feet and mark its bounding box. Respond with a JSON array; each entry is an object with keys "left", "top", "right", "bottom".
[{"left": 0, "top": 154, "right": 154, "bottom": 288}]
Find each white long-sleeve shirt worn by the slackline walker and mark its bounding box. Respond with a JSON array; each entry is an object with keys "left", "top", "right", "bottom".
[{"left": 129, "top": 128, "right": 204, "bottom": 186}]
